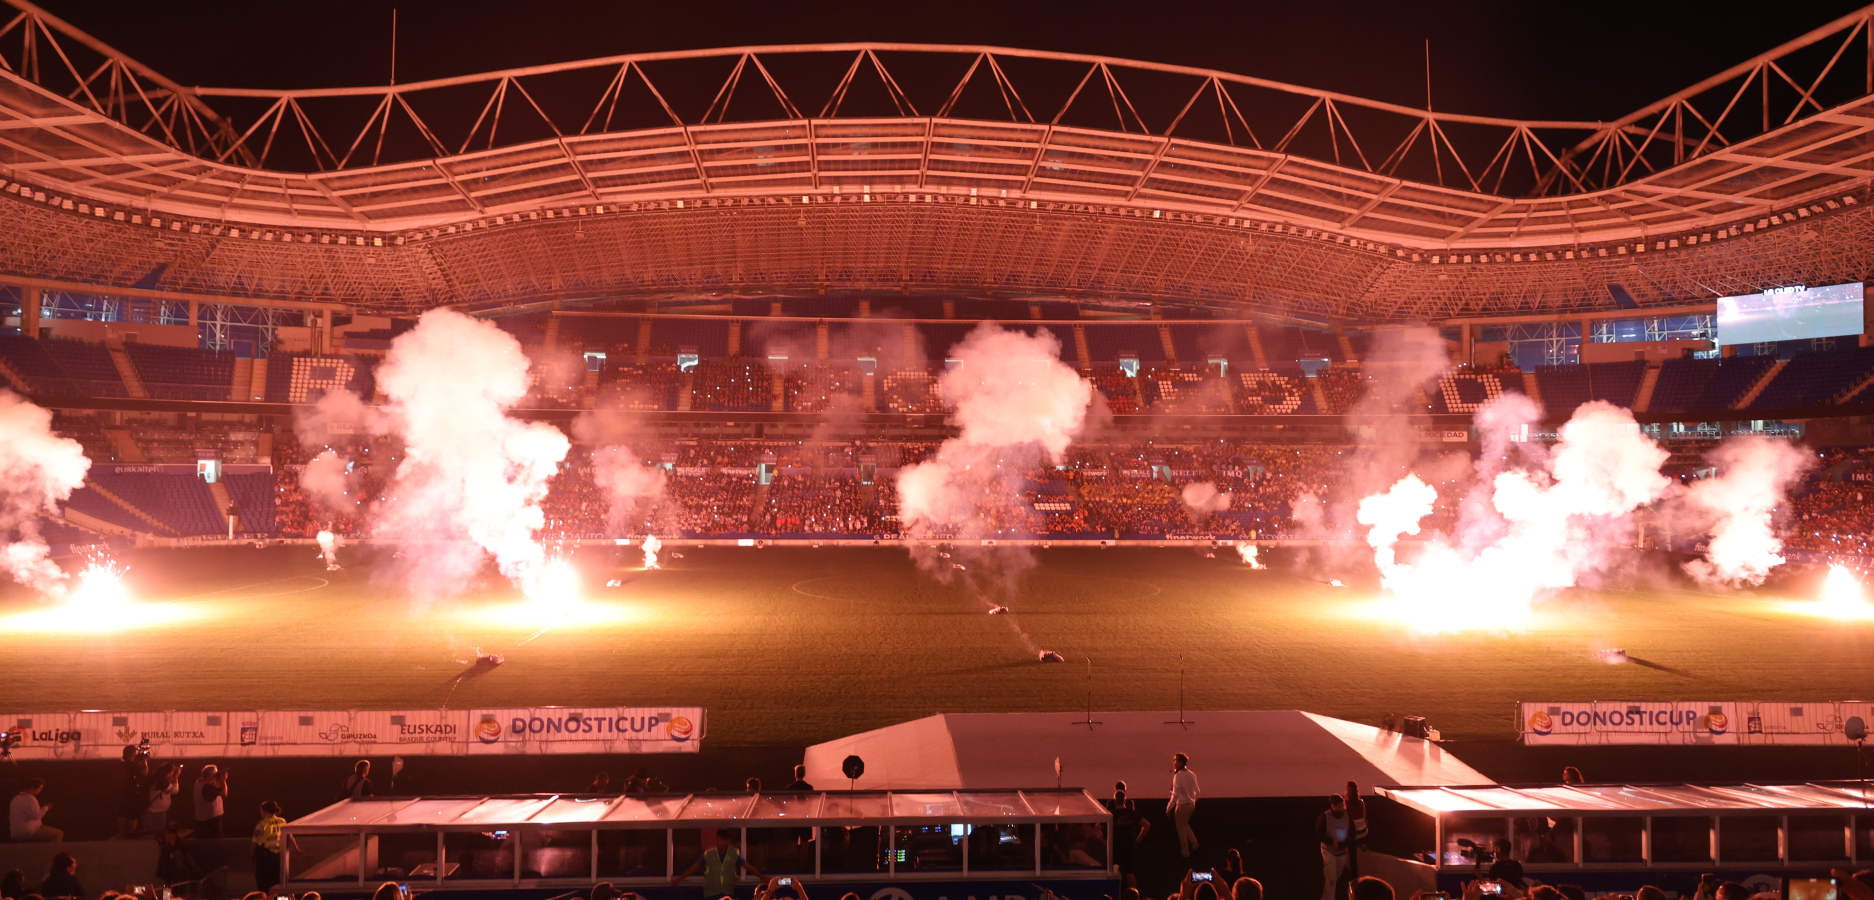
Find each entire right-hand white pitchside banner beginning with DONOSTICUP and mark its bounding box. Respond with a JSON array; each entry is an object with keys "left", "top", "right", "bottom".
[{"left": 1518, "top": 699, "right": 1874, "bottom": 746}]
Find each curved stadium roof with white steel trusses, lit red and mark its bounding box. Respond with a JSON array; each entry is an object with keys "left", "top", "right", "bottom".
[{"left": 0, "top": 0, "right": 1874, "bottom": 321}]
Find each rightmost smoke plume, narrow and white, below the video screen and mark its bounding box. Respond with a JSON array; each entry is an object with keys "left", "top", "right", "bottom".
[{"left": 1685, "top": 437, "right": 1816, "bottom": 587}]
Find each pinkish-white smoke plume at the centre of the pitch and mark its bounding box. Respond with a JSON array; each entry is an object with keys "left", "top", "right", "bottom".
[{"left": 898, "top": 323, "right": 1094, "bottom": 578}]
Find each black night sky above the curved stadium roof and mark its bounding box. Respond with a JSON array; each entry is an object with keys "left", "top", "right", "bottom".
[{"left": 39, "top": 0, "right": 1855, "bottom": 120}]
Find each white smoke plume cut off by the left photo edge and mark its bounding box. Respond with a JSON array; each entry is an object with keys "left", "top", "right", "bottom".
[{"left": 0, "top": 390, "right": 92, "bottom": 593}]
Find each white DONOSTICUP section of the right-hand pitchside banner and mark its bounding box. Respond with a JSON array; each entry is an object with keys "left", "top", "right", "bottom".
[{"left": 1520, "top": 699, "right": 1739, "bottom": 744}]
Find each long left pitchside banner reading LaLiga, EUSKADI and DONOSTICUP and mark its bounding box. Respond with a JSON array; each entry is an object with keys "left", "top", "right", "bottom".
[{"left": 0, "top": 707, "right": 706, "bottom": 759}]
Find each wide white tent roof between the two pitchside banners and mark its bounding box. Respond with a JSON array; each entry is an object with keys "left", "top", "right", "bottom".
[{"left": 806, "top": 709, "right": 1492, "bottom": 797}]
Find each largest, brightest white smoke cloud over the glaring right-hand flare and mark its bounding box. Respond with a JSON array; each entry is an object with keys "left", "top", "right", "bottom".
[{"left": 1359, "top": 399, "right": 1672, "bottom": 632}]
